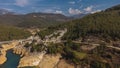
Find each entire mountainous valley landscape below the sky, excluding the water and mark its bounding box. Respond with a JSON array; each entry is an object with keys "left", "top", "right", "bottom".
[{"left": 0, "top": 5, "right": 120, "bottom": 68}]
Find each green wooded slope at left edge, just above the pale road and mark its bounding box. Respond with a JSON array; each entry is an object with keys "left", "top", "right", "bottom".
[{"left": 0, "top": 25, "right": 31, "bottom": 41}]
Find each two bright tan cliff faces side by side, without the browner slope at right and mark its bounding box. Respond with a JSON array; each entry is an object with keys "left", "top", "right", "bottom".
[{"left": 18, "top": 53, "right": 61, "bottom": 68}]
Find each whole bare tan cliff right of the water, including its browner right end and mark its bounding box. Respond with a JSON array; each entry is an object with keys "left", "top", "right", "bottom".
[{"left": 18, "top": 54, "right": 75, "bottom": 68}]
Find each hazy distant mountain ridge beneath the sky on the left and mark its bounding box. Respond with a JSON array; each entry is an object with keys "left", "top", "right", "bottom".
[{"left": 0, "top": 12, "right": 70, "bottom": 28}]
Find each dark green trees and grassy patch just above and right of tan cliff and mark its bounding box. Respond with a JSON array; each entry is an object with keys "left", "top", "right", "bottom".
[{"left": 47, "top": 42, "right": 87, "bottom": 64}]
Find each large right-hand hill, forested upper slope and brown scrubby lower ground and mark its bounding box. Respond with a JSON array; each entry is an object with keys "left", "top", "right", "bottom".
[{"left": 38, "top": 6, "right": 120, "bottom": 68}]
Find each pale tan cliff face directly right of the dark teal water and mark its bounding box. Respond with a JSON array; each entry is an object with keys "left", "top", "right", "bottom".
[{"left": 18, "top": 52, "right": 45, "bottom": 68}]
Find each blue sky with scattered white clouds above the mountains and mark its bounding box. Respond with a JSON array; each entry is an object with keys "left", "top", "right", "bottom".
[{"left": 0, "top": 0, "right": 120, "bottom": 16}]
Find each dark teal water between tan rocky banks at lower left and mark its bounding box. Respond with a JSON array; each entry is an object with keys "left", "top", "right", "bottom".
[{"left": 0, "top": 50, "right": 20, "bottom": 68}]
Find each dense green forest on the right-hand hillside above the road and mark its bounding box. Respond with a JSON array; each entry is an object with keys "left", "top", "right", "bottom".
[{"left": 63, "top": 10, "right": 120, "bottom": 40}]
